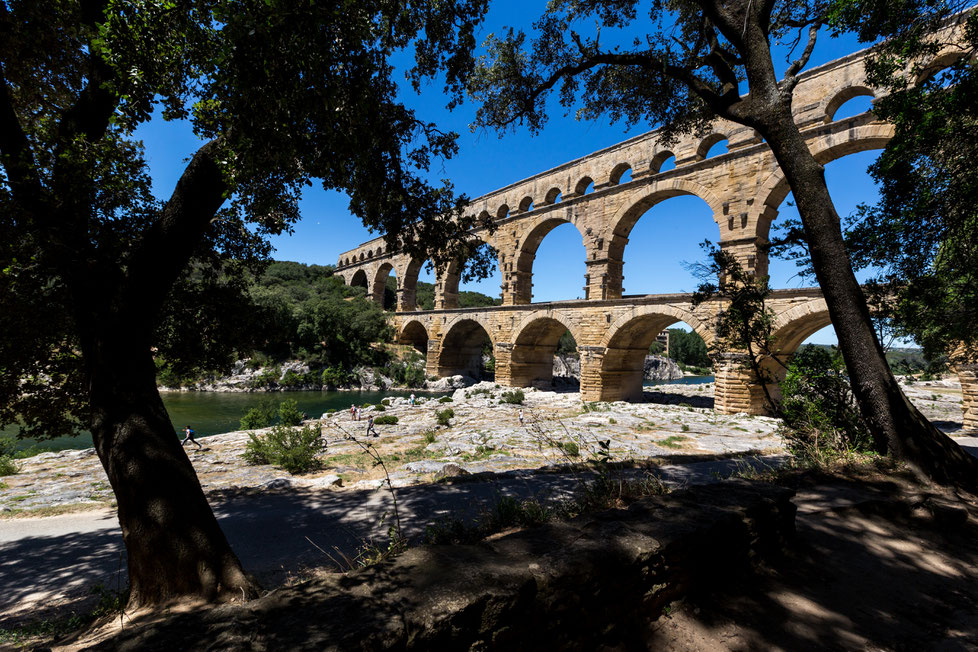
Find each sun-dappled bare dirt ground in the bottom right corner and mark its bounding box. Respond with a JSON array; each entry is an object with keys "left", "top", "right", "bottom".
[{"left": 648, "top": 476, "right": 978, "bottom": 650}]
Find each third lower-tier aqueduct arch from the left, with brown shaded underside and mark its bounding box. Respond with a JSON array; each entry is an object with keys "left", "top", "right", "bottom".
[{"left": 497, "top": 310, "right": 581, "bottom": 387}]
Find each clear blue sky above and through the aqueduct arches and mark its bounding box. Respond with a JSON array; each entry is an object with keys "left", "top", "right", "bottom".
[{"left": 137, "top": 0, "right": 878, "bottom": 343}]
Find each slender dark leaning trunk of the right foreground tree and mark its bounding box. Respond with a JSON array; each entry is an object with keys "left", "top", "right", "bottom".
[{"left": 759, "top": 104, "right": 978, "bottom": 487}]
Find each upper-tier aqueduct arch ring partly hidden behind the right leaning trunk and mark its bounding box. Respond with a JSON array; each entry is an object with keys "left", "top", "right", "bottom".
[{"left": 754, "top": 118, "right": 893, "bottom": 241}]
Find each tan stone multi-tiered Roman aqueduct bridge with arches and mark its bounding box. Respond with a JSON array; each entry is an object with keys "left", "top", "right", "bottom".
[{"left": 336, "top": 45, "right": 978, "bottom": 428}]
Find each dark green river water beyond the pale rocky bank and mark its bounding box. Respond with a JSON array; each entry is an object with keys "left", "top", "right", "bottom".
[{"left": 2, "top": 390, "right": 430, "bottom": 450}]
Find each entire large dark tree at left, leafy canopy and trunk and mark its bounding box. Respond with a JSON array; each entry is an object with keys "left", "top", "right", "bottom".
[{"left": 0, "top": 0, "right": 487, "bottom": 606}]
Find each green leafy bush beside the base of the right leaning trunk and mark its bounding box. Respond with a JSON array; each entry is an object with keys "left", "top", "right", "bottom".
[{"left": 780, "top": 346, "right": 872, "bottom": 464}]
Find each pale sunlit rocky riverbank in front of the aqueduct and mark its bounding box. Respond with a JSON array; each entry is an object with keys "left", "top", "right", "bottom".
[{"left": 0, "top": 380, "right": 961, "bottom": 518}]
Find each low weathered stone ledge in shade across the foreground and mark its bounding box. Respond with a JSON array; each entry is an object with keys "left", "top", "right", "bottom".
[{"left": 100, "top": 481, "right": 795, "bottom": 650}]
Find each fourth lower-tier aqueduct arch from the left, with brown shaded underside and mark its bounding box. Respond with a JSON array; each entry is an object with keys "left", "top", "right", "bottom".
[{"left": 581, "top": 305, "right": 713, "bottom": 401}]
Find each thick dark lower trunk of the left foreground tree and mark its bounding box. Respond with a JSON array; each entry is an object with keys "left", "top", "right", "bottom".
[{"left": 84, "top": 329, "right": 258, "bottom": 607}]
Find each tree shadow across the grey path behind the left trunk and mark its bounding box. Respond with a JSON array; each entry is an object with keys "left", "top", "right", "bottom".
[{"left": 0, "top": 455, "right": 781, "bottom": 629}]
